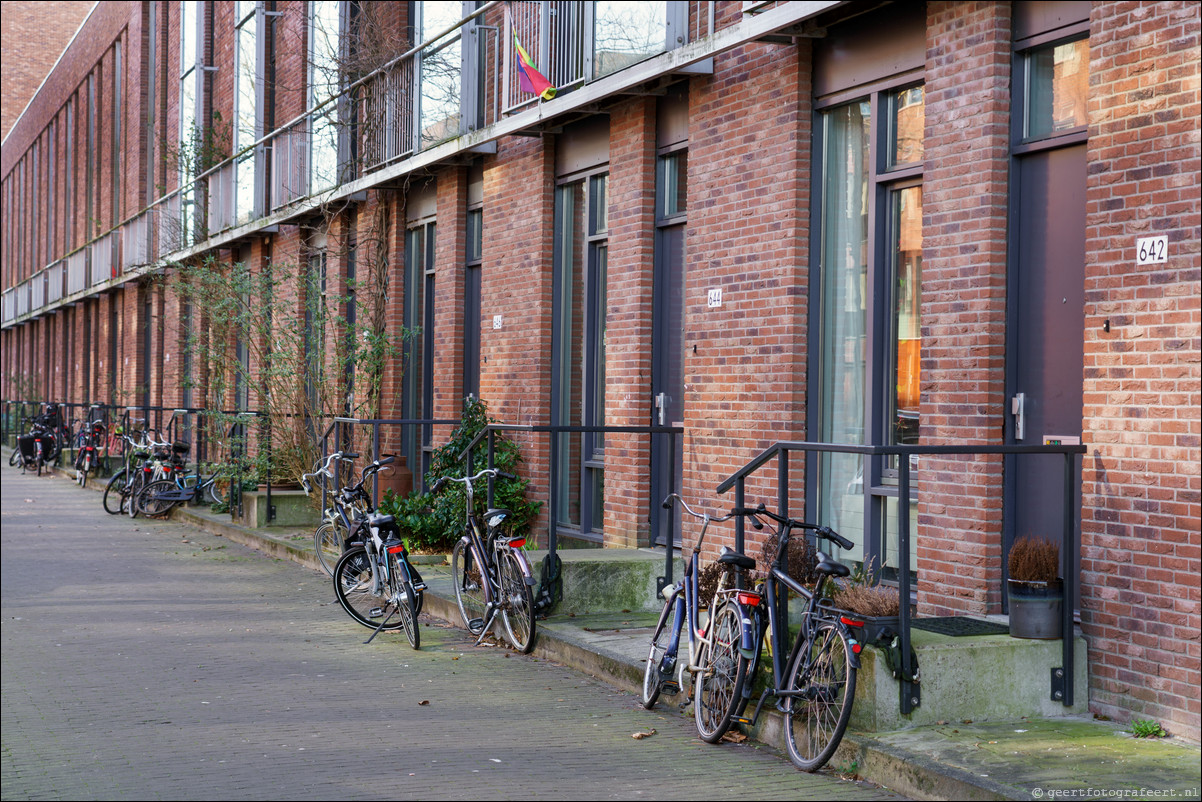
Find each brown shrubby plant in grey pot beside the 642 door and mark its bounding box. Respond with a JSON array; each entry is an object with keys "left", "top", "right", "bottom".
[{"left": 1007, "top": 535, "right": 1064, "bottom": 640}]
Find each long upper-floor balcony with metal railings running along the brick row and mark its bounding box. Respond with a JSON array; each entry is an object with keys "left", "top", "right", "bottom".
[{"left": 2, "top": 0, "right": 844, "bottom": 326}]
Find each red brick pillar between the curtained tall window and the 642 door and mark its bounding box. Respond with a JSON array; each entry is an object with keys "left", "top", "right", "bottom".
[{"left": 912, "top": 2, "right": 1011, "bottom": 616}]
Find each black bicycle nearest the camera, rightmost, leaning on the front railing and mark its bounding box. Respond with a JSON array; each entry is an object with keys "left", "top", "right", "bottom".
[{"left": 719, "top": 504, "right": 861, "bottom": 772}]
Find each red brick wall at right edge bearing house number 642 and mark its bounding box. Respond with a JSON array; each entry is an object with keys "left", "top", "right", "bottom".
[{"left": 1081, "top": 2, "right": 1202, "bottom": 739}]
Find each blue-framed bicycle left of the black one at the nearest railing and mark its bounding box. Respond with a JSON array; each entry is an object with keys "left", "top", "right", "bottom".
[{"left": 643, "top": 493, "right": 762, "bottom": 743}]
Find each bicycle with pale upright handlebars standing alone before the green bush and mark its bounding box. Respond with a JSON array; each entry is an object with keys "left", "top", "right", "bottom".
[{"left": 430, "top": 468, "right": 535, "bottom": 654}]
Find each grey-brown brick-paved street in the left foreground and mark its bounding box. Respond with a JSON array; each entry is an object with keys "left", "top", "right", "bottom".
[{"left": 0, "top": 468, "right": 892, "bottom": 800}]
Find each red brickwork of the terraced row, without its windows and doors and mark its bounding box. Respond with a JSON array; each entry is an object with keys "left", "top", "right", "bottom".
[{"left": 0, "top": 0, "right": 1202, "bottom": 739}]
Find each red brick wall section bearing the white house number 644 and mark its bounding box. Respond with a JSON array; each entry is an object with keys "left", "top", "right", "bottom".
[{"left": 682, "top": 32, "right": 811, "bottom": 552}]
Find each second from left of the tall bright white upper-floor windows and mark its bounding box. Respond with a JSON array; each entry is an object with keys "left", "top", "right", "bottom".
[{"left": 233, "top": 0, "right": 260, "bottom": 224}]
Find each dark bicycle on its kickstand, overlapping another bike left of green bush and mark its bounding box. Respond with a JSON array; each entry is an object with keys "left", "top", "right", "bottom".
[{"left": 333, "top": 457, "right": 426, "bottom": 649}]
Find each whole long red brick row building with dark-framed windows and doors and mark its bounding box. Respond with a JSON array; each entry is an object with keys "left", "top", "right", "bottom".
[{"left": 0, "top": 0, "right": 1202, "bottom": 739}]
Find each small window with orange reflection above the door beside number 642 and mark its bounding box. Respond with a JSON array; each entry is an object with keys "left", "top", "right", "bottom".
[{"left": 1024, "top": 38, "right": 1089, "bottom": 139}]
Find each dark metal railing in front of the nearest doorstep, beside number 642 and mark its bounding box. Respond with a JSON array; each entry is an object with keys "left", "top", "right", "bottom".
[{"left": 718, "top": 441, "right": 1085, "bottom": 715}]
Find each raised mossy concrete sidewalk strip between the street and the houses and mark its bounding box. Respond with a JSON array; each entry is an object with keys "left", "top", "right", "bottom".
[{"left": 28, "top": 450, "right": 1202, "bottom": 800}]
